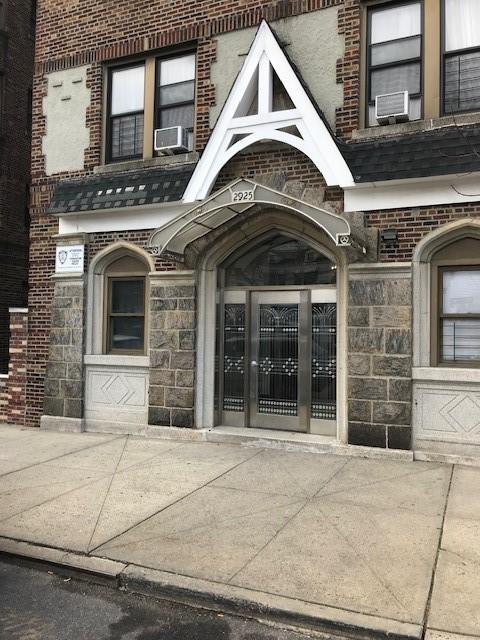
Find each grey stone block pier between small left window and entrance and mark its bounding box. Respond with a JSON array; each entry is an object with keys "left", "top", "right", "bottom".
[{"left": 148, "top": 272, "right": 195, "bottom": 427}]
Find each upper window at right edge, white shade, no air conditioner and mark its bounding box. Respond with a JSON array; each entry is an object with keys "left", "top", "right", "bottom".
[{"left": 443, "top": 0, "right": 480, "bottom": 115}]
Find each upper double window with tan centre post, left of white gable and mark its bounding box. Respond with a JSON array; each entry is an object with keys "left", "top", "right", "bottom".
[{"left": 105, "top": 53, "right": 195, "bottom": 162}]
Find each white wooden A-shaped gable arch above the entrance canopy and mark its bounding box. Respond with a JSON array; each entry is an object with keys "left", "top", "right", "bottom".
[{"left": 184, "top": 21, "right": 354, "bottom": 202}]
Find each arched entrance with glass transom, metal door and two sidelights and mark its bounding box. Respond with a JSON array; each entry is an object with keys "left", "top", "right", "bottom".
[{"left": 215, "top": 231, "right": 337, "bottom": 435}]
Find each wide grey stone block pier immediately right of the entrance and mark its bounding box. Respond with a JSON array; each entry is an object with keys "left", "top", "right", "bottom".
[{"left": 348, "top": 276, "right": 412, "bottom": 449}]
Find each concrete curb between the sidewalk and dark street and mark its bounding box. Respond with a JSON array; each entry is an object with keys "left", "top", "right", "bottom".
[{"left": 0, "top": 537, "right": 423, "bottom": 640}]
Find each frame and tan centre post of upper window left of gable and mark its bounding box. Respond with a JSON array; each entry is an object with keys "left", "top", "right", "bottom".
[{"left": 101, "top": 42, "right": 198, "bottom": 165}]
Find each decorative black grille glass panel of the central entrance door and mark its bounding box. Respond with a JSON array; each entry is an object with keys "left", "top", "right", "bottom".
[{"left": 258, "top": 304, "right": 299, "bottom": 416}]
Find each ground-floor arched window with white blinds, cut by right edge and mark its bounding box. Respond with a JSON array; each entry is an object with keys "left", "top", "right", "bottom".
[{"left": 431, "top": 237, "right": 480, "bottom": 367}]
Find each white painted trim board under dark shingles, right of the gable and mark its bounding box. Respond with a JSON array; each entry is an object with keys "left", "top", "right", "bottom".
[{"left": 344, "top": 173, "right": 480, "bottom": 212}]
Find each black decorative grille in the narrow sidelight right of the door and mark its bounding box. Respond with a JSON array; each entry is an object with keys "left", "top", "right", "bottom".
[{"left": 312, "top": 303, "right": 337, "bottom": 420}]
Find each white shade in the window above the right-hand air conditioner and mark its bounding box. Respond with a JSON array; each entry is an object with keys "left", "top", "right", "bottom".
[{"left": 370, "top": 0, "right": 420, "bottom": 44}]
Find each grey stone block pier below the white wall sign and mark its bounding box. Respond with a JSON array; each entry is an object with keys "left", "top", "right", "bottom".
[{"left": 44, "top": 276, "right": 85, "bottom": 420}]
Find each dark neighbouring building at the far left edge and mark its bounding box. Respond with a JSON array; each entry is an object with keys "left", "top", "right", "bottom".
[{"left": 0, "top": 0, "right": 34, "bottom": 373}]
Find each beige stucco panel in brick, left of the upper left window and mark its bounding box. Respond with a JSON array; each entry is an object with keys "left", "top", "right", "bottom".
[{"left": 42, "top": 66, "right": 90, "bottom": 176}]
